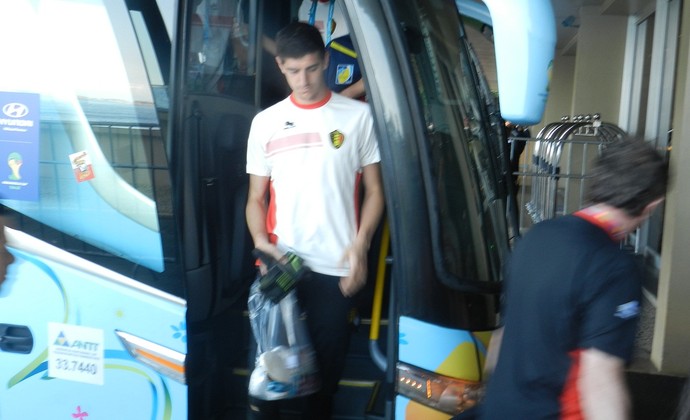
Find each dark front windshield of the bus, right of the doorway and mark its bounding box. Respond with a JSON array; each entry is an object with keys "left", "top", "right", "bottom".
[{"left": 396, "top": 2, "right": 505, "bottom": 291}]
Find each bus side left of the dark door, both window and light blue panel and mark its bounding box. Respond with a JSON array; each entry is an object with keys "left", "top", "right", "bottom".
[{"left": 0, "top": 0, "right": 187, "bottom": 419}]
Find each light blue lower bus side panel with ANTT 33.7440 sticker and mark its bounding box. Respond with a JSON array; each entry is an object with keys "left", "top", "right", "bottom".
[{"left": 0, "top": 234, "right": 187, "bottom": 419}]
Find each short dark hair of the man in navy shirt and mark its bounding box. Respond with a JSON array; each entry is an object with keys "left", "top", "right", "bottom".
[{"left": 589, "top": 139, "right": 668, "bottom": 217}]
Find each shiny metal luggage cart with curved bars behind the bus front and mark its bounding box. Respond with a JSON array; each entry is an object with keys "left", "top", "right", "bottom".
[{"left": 509, "top": 114, "right": 625, "bottom": 233}]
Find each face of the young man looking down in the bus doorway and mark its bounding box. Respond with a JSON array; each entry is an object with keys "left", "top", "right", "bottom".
[{"left": 276, "top": 53, "right": 328, "bottom": 105}]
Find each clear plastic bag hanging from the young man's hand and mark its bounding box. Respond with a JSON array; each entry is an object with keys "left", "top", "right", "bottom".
[{"left": 248, "top": 279, "right": 321, "bottom": 401}]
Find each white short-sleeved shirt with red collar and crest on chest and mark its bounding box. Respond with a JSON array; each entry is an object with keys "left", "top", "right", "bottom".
[{"left": 247, "top": 93, "right": 380, "bottom": 276}]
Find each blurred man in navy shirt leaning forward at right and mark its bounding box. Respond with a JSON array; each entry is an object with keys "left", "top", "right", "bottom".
[{"left": 479, "top": 140, "right": 668, "bottom": 420}]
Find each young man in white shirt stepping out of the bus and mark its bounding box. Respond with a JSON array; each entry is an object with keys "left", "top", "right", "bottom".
[{"left": 246, "top": 22, "right": 384, "bottom": 419}]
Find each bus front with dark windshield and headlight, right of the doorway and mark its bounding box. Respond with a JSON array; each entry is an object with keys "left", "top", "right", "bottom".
[{"left": 344, "top": 0, "right": 553, "bottom": 419}]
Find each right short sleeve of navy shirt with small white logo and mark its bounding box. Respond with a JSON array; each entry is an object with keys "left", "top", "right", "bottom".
[{"left": 578, "top": 258, "right": 641, "bottom": 361}]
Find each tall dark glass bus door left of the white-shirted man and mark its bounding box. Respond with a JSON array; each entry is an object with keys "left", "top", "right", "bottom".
[{"left": 170, "top": 0, "right": 300, "bottom": 419}]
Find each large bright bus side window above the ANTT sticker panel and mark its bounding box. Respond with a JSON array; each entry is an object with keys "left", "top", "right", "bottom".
[{"left": 0, "top": 0, "right": 182, "bottom": 296}]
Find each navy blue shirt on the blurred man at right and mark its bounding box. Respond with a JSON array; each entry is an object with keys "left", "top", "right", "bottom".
[{"left": 481, "top": 215, "right": 641, "bottom": 420}]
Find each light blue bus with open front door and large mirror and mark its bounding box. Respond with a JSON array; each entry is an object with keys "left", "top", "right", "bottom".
[{"left": 0, "top": 0, "right": 555, "bottom": 420}]
